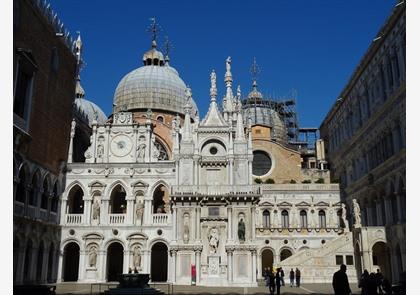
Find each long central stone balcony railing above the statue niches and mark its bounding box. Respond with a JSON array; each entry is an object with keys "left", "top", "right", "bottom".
[{"left": 171, "top": 185, "right": 261, "bottom": 196}]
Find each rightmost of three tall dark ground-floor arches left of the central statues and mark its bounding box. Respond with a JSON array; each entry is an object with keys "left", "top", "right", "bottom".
[{"left": 150, "top": 242, "right": 168, "bottom": 282}]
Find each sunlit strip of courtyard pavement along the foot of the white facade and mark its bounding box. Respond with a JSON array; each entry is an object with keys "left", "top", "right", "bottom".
[{"left": 56, "top": 283, "right": 360, "bottom": 295}]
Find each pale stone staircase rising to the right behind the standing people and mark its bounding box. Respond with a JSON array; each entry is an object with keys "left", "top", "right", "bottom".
[{"left": 276, "top": 232, "right": 357, "bottom": 283}]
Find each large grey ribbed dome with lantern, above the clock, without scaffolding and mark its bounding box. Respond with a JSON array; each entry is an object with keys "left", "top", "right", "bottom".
[{"left": 114, "top": 42, "right": 197, "bottom": 115}]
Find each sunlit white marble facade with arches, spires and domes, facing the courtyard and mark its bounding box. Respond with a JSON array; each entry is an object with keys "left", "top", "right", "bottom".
[{"left": 57, "top": 27, "right": 356, "bottom": 286}]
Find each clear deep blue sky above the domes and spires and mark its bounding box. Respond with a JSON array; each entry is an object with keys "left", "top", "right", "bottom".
[{"left": 50, "top": 0, "right": 396, "bottom": 127}]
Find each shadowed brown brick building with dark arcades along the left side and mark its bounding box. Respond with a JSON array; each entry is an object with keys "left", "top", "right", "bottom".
[{"left": 13, "top": 0, "right": 77, "bottom": 285}]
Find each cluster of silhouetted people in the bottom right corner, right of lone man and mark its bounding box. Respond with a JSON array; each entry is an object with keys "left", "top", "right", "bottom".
[{"left": 359, "top": 269, "right": 392, "bottom": 295}]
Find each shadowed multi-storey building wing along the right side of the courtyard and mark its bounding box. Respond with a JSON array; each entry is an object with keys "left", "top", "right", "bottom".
[{"left": 320, "top": 1, "right": 406, "bottom": 282}]
